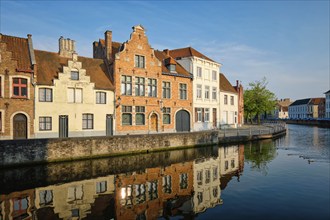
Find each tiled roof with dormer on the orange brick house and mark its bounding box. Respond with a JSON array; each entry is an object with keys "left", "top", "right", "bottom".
[{"left": 154, "top": 50, "right": 192, "bottom": 78}]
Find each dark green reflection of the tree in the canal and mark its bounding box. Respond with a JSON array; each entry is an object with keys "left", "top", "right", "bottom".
[{"left": 244, "top": 140, "right": 277, "bottom": 176}]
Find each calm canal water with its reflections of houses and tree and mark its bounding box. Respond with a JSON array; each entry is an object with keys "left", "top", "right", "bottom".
[{"left": 0, "top": 125, "right": 330, "bottom": 220}]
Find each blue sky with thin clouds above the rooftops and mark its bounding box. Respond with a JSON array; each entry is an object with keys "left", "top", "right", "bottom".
[{"left": 0, "top": 0, "right": 330, "bottom": 100}]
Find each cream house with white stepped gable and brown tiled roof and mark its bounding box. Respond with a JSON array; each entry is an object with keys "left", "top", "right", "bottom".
[{"left": 35, "top": 37, "right": 114, "bottom": 138}]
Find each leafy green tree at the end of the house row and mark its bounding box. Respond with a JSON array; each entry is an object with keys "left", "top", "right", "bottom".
[{"left": 244, "top": 77, "right": 276, "bottom": 124}]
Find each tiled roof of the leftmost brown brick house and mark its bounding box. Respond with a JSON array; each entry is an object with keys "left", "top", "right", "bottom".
[{"left": 0, "top": 34, "right": 32, "bottom": 72}]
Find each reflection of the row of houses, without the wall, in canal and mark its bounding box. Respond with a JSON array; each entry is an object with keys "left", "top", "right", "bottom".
[{"left": 0, "top": 145, "right": 244, "bottom": 220}]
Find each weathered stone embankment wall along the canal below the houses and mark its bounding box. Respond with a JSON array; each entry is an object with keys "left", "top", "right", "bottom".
[{"left": 0, "top": 124, "right": 286, "bottom": 168}]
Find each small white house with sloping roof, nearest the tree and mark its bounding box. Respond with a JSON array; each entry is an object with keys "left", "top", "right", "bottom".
[{"left": 219, "top": 73, "right": 239, "bottom": 128}]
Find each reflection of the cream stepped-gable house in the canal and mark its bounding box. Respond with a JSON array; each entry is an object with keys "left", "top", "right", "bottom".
[{"left": 35, "top": 175, "right": 115, "bottom": 220}]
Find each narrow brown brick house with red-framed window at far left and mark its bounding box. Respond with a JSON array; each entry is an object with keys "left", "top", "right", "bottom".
[{"left": 0, "top": 34, "right": 36, "bottom": 139}]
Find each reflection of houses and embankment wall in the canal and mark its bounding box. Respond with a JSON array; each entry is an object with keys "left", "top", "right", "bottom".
[{"left": 0, "top": 145, "right": 244, "bottom": 220}]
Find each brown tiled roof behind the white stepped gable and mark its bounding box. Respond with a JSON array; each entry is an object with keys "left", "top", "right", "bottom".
[{"left": 35, "top": 50, "right": 114, "bottom": 90}]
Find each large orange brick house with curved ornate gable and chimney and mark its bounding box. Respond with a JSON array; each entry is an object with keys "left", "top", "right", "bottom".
[{"left": 93, "top": 25, "right": 192, "bottom": 134}]
